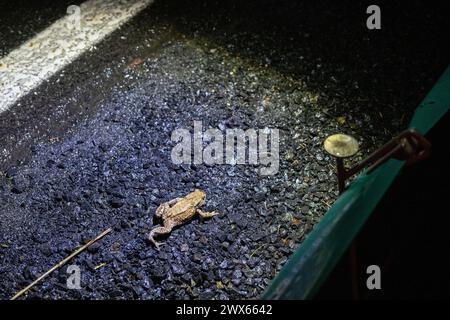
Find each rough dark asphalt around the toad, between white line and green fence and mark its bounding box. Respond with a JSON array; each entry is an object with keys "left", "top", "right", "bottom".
[{"left": 0, "top": 0, "right": 449, "bottom": 299}]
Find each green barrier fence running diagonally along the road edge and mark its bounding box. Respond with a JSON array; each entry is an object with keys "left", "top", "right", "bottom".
[{"left": 261, "top": 67, "right": 450, "bottom": 299}]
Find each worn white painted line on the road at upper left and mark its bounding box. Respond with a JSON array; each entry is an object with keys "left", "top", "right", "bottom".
[{"left": 0, "top": 0, "right": 153, "bottom": 113}]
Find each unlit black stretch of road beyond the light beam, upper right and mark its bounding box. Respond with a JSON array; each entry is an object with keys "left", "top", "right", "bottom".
[{"left": 151, "top": 0, "right": 450, "bottom": 124}]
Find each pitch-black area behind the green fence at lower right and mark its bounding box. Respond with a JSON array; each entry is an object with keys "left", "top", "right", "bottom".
[{"left": 317, "top": 114, "right": 450, "bottom": 299}]
